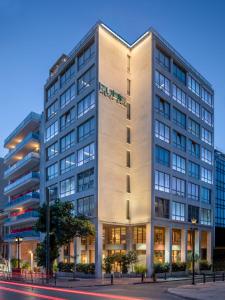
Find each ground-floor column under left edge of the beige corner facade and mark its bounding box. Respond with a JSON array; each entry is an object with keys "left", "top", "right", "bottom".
[{"left": 95, "top": 222, "right": 103, "bottom": 278}]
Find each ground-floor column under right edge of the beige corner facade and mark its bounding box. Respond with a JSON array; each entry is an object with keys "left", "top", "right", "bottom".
[{"left": 146, "top": 223, "right": 154, "bottom": 277}]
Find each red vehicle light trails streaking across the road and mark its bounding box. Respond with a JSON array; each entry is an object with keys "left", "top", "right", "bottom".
[{"left": 0, "top": 280, "right": 143, "bottom": 300}]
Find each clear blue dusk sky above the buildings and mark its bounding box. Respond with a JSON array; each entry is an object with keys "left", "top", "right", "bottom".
[{"left": 0, "top": 0, "right": 225, "bottom": 156}]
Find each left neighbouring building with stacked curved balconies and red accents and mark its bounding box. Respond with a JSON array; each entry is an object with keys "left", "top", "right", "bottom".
[{"left": 4, "top": 112, "right": 41, "bottom": 263}]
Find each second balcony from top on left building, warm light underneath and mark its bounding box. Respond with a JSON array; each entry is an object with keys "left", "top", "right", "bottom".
[{"left": 4, "top": 132, "right": 40, "bottom": 164}]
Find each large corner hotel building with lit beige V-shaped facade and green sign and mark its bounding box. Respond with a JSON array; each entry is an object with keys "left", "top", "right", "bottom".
[{"left": 41, "top": 23, "right": 214, "bottom": 276}]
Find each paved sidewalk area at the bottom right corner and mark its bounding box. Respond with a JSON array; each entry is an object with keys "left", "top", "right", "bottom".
[{"left": 168, "top": 282, "right": 225, "bottom": 300}]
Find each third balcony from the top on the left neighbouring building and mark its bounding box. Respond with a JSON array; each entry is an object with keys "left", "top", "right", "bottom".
[{"left": 4, "top": 152, "right": 40, "bottom": 180}]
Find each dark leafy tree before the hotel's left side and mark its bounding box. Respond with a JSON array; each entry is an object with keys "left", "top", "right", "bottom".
[{"left": 35, "top": 200, "right": 95, "bottom": 270}]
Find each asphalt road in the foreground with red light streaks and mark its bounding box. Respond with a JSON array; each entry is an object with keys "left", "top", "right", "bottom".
[{"left": 0, "top": 281, "right": 184, "bottom": 300}]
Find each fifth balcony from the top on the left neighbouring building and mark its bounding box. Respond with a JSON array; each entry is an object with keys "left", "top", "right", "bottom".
[{"left": 4, "top": 192, "right": 40, "bottom": 211}]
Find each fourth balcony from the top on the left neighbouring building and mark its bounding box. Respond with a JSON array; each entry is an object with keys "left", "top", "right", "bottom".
[{"left": 4, "top": 172, "right": 40, "bottom": 196}]
